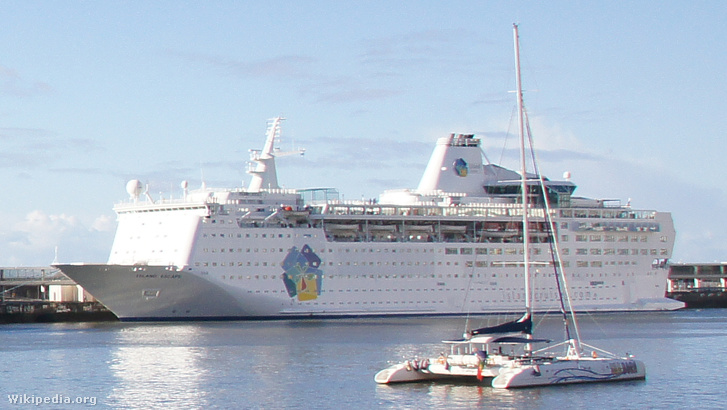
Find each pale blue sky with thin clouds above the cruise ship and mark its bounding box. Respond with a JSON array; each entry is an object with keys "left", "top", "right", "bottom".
[{"left": 0, "top": 0, "right": 727, "bottom": 267}]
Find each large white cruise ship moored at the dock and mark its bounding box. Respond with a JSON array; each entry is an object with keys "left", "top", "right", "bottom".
[{"left": 55, "top": 118, "right": 683, "bottom": 321}]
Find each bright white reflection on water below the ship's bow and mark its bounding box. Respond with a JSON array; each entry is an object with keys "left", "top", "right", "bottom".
[{"left": 107, "top": 325, "right": 207, "bottom": 409}]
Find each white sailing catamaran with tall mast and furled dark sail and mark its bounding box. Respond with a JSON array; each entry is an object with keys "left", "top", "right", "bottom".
[{"left": 374, "top": 25, "right": 646, "bottom": 388}]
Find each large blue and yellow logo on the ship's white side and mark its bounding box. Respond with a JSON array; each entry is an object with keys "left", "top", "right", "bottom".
[{"left": 281, "top": 245, "right": 323, "bottom": 301}]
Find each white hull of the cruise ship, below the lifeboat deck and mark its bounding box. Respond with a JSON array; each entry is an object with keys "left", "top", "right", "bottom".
[{"left": 56, "top": 211, "right": 683, "bottom": 320}]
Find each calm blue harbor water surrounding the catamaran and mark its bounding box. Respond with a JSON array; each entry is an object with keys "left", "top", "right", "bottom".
[{"left": 0, "top": 309, "right": 727, "bottom": 409}]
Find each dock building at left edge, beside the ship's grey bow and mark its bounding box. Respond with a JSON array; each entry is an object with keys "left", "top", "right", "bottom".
[{"left": 0, "top": 267, "right": 116, "bottom": 323}]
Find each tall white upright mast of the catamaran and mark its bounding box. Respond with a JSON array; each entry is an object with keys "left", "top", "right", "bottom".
[{"left": 512, "top": 24, "right": 532, "bottom": 316}]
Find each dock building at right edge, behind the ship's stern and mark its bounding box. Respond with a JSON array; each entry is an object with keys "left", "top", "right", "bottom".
[{"left": 666, "top": 262, "right": 727, "bottom": 308}]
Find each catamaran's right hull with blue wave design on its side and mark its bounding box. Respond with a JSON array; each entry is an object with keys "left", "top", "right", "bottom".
[{"left": 492, "top": 358, "right": 646, "bottom": 389}]
